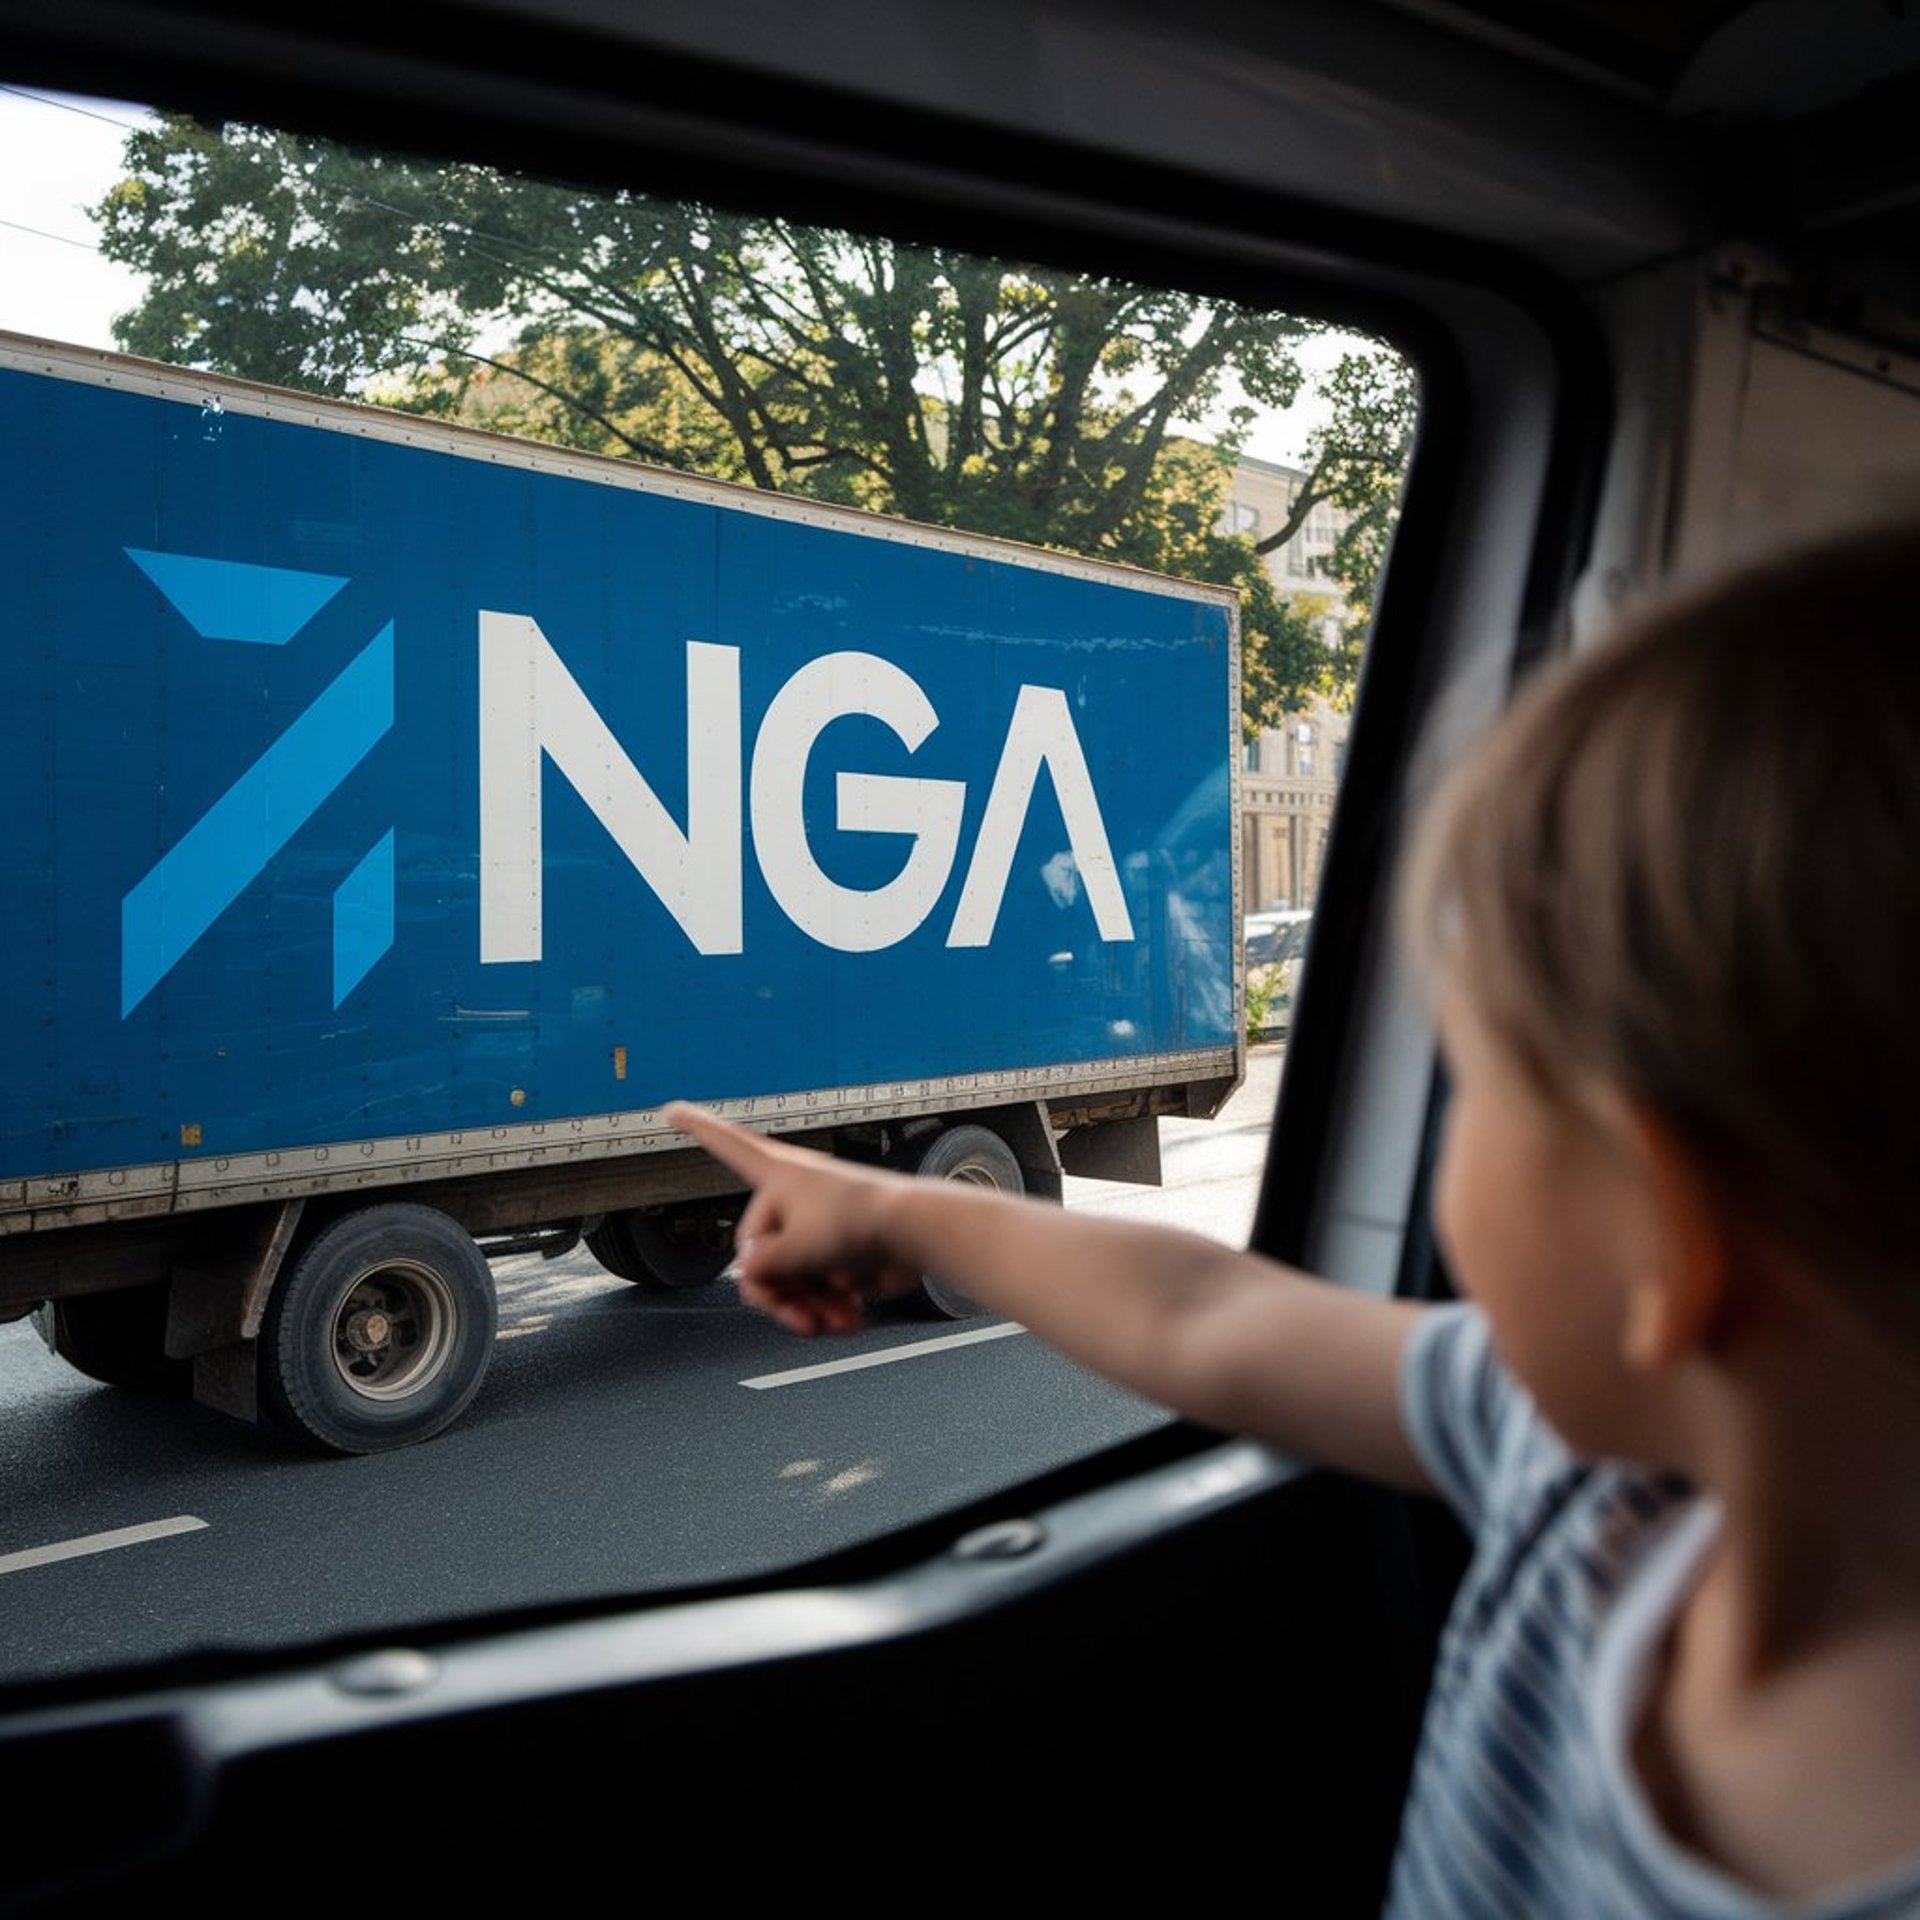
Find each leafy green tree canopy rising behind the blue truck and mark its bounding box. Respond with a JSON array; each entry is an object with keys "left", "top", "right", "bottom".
[{"left": 94, "top": 115, "right": 1384, "bottom": 726}]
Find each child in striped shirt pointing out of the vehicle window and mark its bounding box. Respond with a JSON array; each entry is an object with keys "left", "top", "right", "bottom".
[{"left": 672, "top": 530, "right": 1920, "bottom": 1920}]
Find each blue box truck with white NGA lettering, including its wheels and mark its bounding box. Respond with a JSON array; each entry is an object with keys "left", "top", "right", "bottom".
[{"left": 0, "top": 334, "right": 1246, "bottom": 1453}]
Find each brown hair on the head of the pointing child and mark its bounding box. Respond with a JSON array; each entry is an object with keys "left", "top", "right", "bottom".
[{"left": 1404, "top": 526, "right": 1920, "bottom": 1338}]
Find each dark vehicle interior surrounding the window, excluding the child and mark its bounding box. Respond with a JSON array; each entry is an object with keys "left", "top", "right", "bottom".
[{"left": 0, "top": 0, "right": 1920, "bottom": 1920}]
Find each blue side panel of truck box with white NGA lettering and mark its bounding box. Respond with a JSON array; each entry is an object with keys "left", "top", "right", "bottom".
[{"left": 0, "top": 336, "right": 1236, "bottom": 1202}]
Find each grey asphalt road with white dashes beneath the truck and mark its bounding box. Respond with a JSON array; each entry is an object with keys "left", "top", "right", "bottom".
[{"left": 0, "top": 1048, "right": 1281, "bottom": 1684}]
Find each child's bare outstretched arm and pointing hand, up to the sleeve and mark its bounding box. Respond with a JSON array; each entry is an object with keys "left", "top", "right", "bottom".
[{"left": 666, "top": 1104, "right": 1430, "bottom": 1490}]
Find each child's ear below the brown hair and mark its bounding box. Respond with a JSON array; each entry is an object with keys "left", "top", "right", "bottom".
[{"left": 1620, "top": 1102, "right": 1730, "bottom": 1373}]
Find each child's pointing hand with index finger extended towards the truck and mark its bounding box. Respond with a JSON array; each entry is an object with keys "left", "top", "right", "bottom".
[{"left": 666, "top": 1100, "right": 920, "bottom": 1334}]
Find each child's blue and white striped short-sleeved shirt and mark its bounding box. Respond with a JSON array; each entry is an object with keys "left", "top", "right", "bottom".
[{"left": 1388, "top": 1306, "right": 1920, "bottom": 1920}]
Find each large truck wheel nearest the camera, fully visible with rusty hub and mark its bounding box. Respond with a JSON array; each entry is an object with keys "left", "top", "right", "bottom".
[{"left": 259, "top": 1204, "right": 499, "bottom": 1453}]
